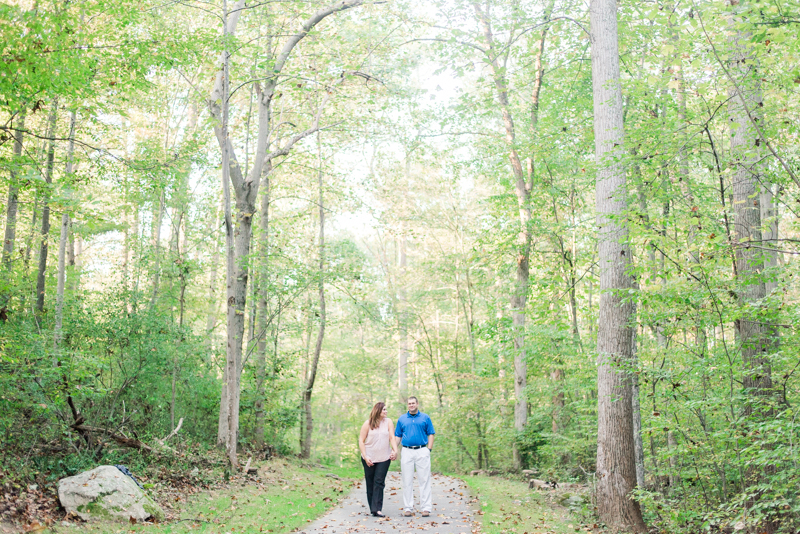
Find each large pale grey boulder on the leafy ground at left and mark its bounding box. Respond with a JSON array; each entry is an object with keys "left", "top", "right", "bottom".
[{"left": 58, "top": 465, "right": 164, "bottom": 521}]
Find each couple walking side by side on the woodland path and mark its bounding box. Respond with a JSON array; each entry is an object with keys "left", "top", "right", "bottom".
[{"left": 358, "top": 397, "right": 435, "bottom": 517}]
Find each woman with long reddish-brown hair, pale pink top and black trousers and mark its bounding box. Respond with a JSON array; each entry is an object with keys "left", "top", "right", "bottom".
[{"left": 358, "top": 402, "right": 397, "bottom": 517}]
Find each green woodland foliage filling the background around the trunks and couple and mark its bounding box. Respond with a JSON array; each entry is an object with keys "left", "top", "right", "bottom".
[{"left": 0, "top": 0, "right": 800, "bottom": 533}]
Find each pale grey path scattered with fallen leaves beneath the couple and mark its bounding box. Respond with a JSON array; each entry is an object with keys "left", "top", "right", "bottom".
[{"left": 300, "top": 471, "right": 479, "bottom": 534}]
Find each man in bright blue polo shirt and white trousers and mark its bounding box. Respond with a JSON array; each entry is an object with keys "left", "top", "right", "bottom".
[{"left": 394, "top": 397, "right": 436, "bottom": 517}]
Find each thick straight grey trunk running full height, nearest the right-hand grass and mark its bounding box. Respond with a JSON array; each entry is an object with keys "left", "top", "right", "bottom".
[{"left": 590, "top": 0, "right": 646, "bottom": 532}]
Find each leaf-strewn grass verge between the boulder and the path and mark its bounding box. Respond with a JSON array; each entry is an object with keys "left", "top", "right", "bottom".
[{"left": 54, "top": 459, "right": 353, "bottom": 534}]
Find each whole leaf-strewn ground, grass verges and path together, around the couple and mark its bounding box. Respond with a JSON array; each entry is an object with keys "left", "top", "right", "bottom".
[{"left": 0, "top": 458, "right": 601, "bottom": 534}]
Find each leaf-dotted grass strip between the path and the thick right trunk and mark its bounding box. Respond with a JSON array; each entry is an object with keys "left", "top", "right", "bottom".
[{"left": 461, "top": 476, "right": 599, "bottom": 534}]
